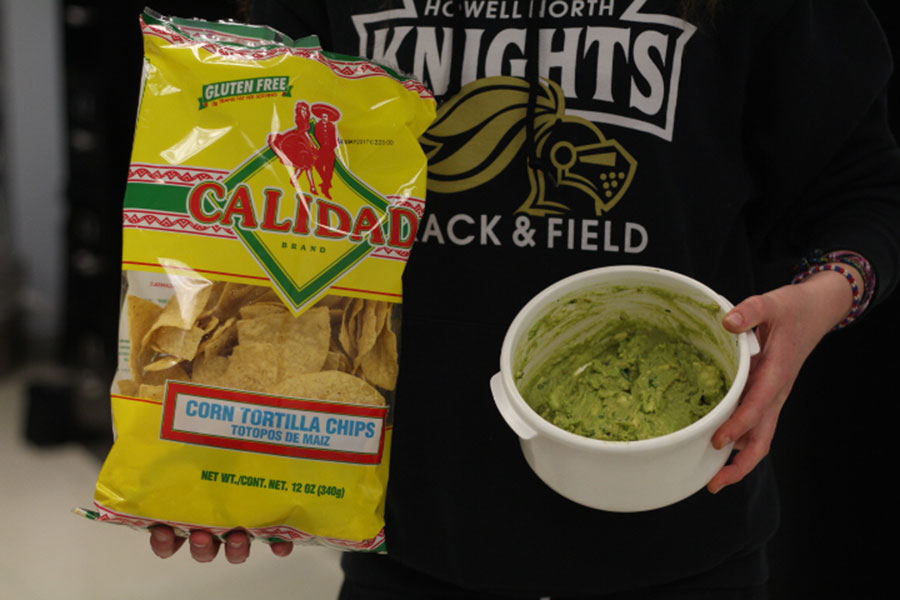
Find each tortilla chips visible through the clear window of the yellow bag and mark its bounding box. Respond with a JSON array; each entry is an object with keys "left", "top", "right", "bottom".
[{"left": 123, "top": 282, "right": 398, "bottom": 404}]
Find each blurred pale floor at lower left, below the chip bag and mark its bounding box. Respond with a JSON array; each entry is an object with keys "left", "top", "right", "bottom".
[{"left": 0, "top": 373, "right": 341, "bottom": 600}]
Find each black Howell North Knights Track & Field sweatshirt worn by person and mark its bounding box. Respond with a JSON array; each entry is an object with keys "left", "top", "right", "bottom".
[{"left": 253, "top": 0, "right": 900, "bottom": 595}]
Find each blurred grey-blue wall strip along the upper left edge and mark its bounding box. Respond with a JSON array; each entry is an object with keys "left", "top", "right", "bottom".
[{"left": 0, "top": 0, "right": 66, "bottom": 368}]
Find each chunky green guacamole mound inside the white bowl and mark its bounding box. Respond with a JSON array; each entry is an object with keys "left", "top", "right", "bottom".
[{"left": 520, "top": 315, "right": 728, "bottom": 441}]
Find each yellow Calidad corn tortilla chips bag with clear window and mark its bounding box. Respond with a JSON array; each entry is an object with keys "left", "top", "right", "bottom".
[{"left": 79, "top": 10, "right": 435, "bottom": 551}]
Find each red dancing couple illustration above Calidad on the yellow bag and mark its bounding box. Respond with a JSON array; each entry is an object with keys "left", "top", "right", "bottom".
[{"left": 268, "top": 100, "right": 341, "bottom": 200}]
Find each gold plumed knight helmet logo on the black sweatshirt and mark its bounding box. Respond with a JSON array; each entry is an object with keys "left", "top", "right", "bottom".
[{"left": 421, "top": 77, "right": 637, "bottom": 216}]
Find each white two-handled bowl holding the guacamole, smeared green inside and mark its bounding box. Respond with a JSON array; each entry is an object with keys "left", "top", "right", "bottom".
[{"left": 491, "top": 266, "right": 759, "bottom": 512}]
